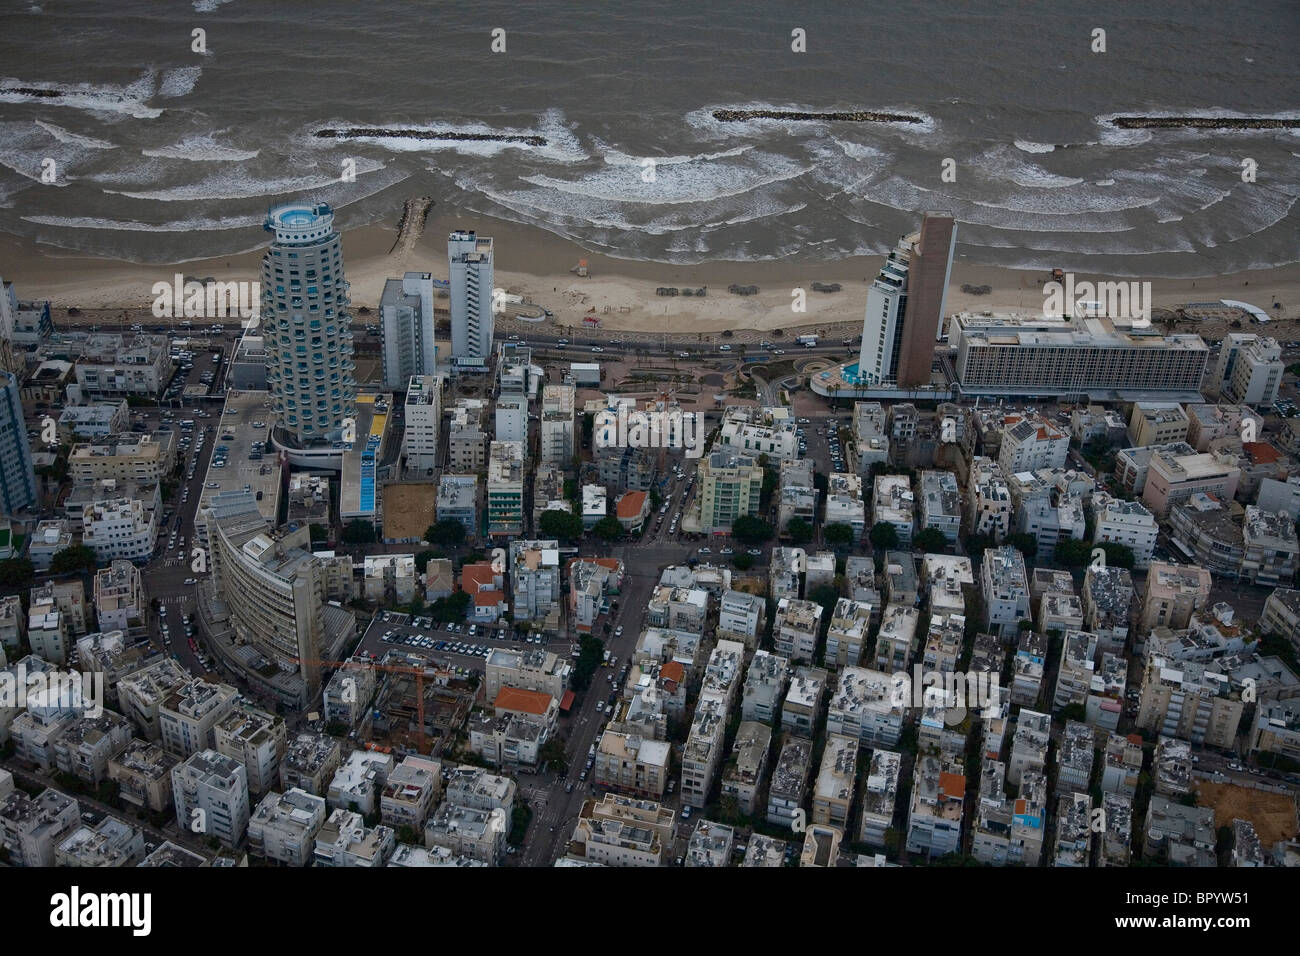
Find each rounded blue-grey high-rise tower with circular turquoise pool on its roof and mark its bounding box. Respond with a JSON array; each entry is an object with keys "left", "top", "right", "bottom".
[{"left": 261, "top": 203, "right": 356, "bottom": 447}]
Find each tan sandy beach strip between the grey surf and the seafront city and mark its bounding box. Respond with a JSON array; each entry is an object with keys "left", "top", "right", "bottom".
[{"left": 0, "top": 207, "right": 1300, "bottom": 334}]
